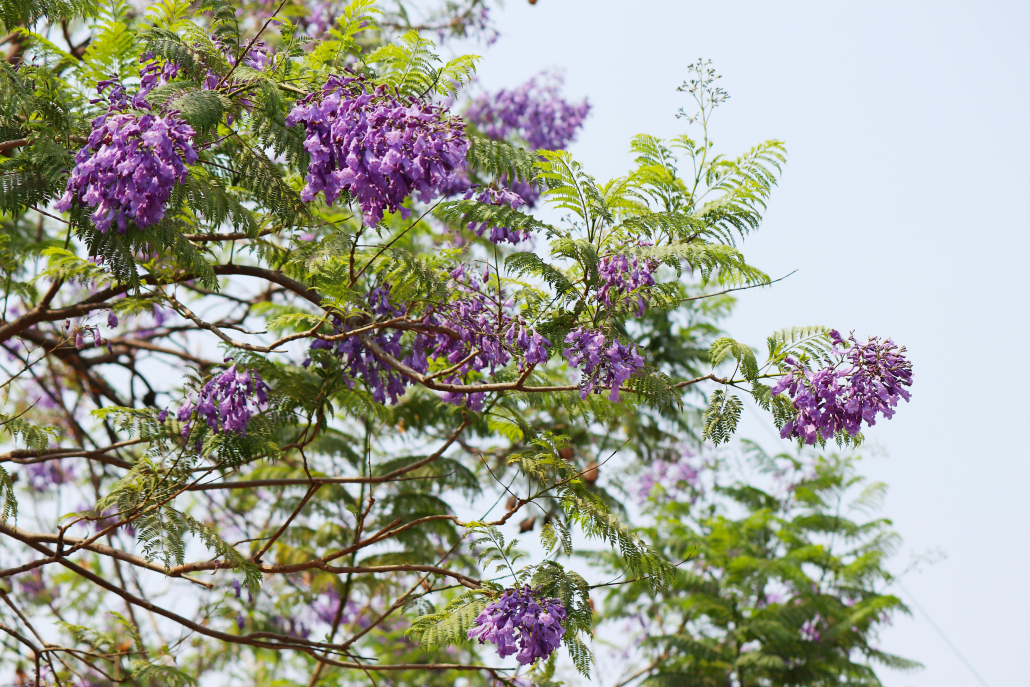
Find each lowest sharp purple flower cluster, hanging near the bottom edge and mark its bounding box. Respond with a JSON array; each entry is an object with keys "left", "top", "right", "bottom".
[{"left": 469, "top": 585, "right": 565, "bottom": 665}]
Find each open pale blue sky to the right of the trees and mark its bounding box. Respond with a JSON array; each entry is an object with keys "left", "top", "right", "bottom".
[{"left": 469, "top": 0, "right": 1030, "bottom": 687}]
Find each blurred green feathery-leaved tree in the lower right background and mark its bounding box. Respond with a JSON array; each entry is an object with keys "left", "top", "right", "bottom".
[{"left": 598, "top": 444, "right": 919, "bottom": 686}]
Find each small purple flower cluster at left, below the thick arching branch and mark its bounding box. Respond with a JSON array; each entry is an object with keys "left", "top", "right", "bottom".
[{"left": 176, "top": 358, "right": 268, "bottom": 439}]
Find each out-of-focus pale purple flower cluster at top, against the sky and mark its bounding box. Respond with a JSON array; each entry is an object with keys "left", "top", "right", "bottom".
[{"left": 466, "top": 74, "right": 590, "bottom": 150}]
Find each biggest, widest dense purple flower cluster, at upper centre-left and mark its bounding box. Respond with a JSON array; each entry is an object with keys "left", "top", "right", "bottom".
[{"left": 286, "top": 76, "right": 469, "bottom": 227}]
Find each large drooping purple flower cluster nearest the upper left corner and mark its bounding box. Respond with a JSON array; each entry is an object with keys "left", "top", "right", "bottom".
[{"left": 55, "top": 55, "right": 198, "bottom": 234}]
